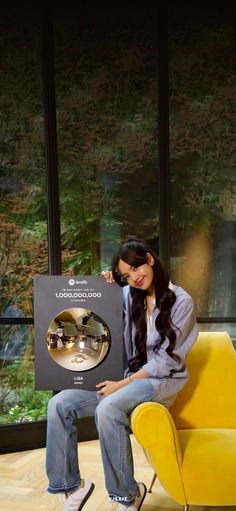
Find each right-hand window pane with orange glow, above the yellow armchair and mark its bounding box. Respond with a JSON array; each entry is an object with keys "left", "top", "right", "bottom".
[{"left": 169, "top": 5, "right": 236, "bottom": 316}]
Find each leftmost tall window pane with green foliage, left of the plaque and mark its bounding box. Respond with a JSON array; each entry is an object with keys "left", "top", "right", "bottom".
[{"left": 0, "top": 6, "right": 49, "bottom": 423}]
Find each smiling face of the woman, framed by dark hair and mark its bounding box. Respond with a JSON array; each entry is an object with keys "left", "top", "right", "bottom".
[{"left": 118, "top": 254, "right": 154, "bottom": 293}]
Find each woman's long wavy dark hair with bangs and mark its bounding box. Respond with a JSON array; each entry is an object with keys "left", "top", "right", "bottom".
[{"left": 112, "top": 238, "right": 176, "bottom": 372}]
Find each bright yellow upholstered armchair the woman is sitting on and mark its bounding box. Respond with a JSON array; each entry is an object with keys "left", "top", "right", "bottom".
[{"left": 131, "top": 332, "right": 236, "bottom": 510}]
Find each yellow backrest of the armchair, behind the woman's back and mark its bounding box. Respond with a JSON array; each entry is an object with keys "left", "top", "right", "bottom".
[{"left": 170, "top": 332, "right": 236, "bottom": 429}]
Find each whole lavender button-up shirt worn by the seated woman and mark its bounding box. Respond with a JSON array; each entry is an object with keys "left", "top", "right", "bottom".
[{"left": 123, "top": 283, "right": 198, "bottom": 406}]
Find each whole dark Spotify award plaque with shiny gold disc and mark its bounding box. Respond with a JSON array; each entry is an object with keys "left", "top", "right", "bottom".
[{"left": 34, "top": 275, "right": 123, "bottom": 390}]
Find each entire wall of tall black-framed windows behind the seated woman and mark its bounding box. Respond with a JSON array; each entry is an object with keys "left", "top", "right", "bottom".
[{"left": 0, "top": 0, "right": 236, "bottom": 442}]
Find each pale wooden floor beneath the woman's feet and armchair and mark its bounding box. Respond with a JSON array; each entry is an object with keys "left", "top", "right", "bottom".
[{"left": 0, "top": 436, "right": 236, "bottom": 511}]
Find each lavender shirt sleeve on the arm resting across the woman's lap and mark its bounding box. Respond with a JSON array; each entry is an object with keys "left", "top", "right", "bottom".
[{"left": 143, "top": 297, "right": 198, "bottom": 378}]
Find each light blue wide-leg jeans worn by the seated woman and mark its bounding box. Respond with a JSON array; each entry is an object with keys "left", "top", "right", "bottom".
[{"left": 46, "top": 378, "right": 154, "bottom": 505}]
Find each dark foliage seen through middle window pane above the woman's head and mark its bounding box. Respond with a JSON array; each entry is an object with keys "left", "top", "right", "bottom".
[{"left": 54, "top": 3, "right": 158, "bottom": 274}]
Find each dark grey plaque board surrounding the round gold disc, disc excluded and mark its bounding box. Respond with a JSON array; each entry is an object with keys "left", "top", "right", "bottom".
[{"left": 34, "top": 275, "right": 123, "bottom": 391}]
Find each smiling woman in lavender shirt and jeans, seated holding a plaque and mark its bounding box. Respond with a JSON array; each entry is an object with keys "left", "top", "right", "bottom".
[{"left": 47, "top": 239, "right": 197, "bottom": 511}]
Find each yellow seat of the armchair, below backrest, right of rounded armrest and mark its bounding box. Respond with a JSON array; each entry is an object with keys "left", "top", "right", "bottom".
[{"left": 178, "top": 428, "right": 236, "bottom": 506}]
